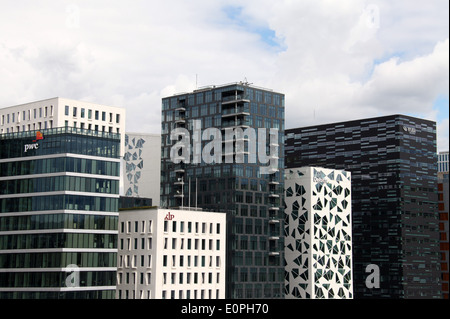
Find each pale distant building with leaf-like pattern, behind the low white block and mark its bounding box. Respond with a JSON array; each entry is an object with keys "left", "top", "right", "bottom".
[{"left": 123, "top": 133, "right": 161, "bottom": 206}]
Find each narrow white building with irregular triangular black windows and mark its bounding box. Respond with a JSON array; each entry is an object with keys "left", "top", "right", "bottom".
[{"left": 285, "top": 167, "right": 353, "bottom": 299}]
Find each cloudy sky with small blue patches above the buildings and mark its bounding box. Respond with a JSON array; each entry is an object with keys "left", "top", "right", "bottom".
[{"left": 0, "top": 0, "right": 449, "bottom": 151}]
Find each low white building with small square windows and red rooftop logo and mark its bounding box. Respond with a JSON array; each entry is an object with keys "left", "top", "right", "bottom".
[{"left": 116, "top": 209, "right": 226, "bottom": 299}]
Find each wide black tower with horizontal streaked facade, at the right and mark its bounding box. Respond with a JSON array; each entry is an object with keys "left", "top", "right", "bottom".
[{"left": 285, "top": 115, "right": 440, "bottom": 298}]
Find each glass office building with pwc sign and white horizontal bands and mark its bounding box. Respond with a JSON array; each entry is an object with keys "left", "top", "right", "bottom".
[{"left": 0, "top": 127, "right": 120, "bottom": 299}]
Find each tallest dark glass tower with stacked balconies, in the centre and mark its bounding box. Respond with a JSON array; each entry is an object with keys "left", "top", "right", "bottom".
[{"left": 161, "top": 83, "right": 284, "bottom": 298}]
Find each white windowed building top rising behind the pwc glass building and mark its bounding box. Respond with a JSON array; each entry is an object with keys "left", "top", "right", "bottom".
[{"left": 0, "top": 97, "right": 126, "bottom": 156}]
